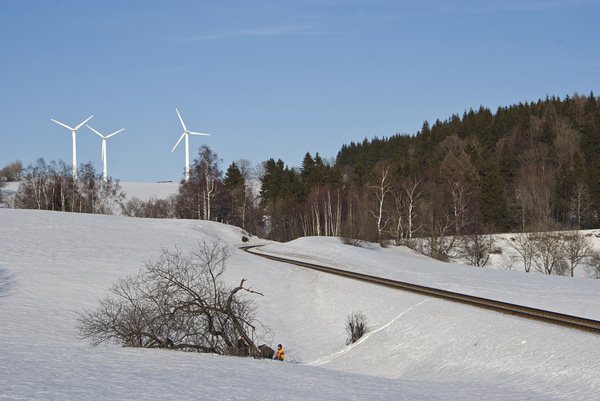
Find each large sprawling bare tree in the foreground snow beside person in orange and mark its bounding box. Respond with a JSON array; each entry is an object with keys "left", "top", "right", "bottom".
[{"left": 79, "top": 242, "right": 262, "bottom": 355}]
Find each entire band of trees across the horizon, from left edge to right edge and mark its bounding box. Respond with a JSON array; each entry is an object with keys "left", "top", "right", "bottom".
[{"left": 5, "top": 93, "right": 600, "bottom": 265}]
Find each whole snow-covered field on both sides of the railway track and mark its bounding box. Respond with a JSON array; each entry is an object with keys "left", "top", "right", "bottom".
[{"left": 0, "top": 183, "right": 600, "bottom": 400}]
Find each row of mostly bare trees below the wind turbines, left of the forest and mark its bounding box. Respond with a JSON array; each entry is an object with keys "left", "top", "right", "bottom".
[{"left": 0, "top": 146, "right": 265, "bottom": 235}]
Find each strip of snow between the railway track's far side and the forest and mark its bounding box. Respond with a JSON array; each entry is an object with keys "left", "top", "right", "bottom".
[{"left": 259, "top": 237, "right": 600, "bottom": 320}]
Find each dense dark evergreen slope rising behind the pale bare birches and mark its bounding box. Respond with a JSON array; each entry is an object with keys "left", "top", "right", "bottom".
[{"left": 336, "top": 93, "right": 600, "bottom": 232}]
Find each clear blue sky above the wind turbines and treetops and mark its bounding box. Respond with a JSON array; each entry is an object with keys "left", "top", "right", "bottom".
[{"left": 0, "top": 0, "right": 600, "bottom": 182}]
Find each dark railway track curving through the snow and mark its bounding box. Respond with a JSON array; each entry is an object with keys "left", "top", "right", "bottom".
[{"left": 240, "top": 245, "right": 600, "bottom": 335}]
